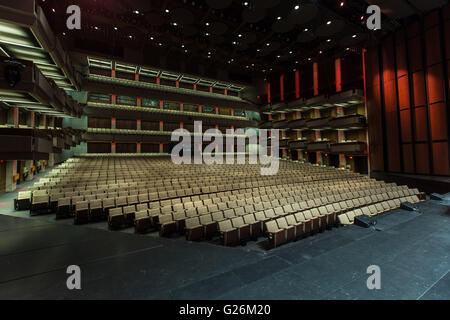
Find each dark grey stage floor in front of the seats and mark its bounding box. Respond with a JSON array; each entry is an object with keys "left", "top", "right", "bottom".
[{"left": 0, "top": 190, "right": 450, "bottom": 300}]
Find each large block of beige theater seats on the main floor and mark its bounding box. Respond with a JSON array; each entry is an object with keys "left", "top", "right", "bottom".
[{"left": 20, "top": 159, "right": 420, "bottom": 246}]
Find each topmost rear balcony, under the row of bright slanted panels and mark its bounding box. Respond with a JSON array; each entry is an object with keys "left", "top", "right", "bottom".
[{"left": 83, "top": 57, "right": 258, "bottom": 111}]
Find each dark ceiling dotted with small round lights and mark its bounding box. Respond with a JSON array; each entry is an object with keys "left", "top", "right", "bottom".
[{"left": 38, "top": 0, "right": 446, "bottom": 84}]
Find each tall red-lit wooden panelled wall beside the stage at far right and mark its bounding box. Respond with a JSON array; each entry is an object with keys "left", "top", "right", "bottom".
[{"left": 366, "top": 5, "right": 450, "bottom": 176}]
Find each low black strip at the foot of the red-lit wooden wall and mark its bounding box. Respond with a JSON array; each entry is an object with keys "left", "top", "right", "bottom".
[{"left": 370, "top": 171, "right": 450, "bottom": 194}]
